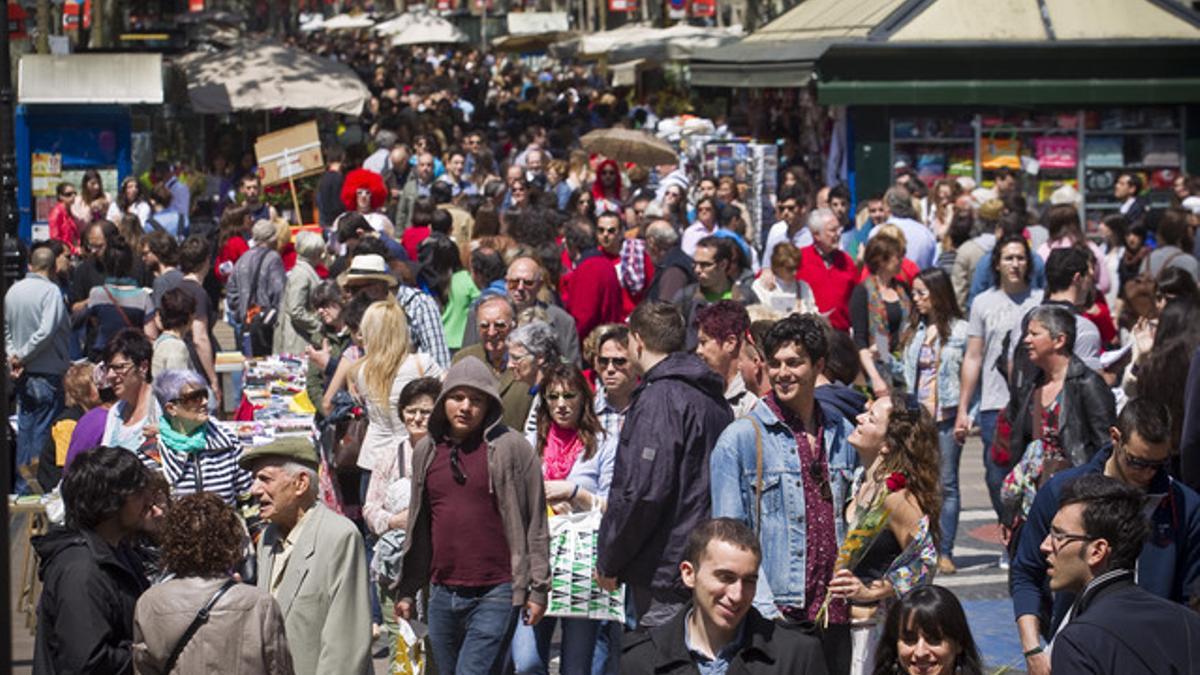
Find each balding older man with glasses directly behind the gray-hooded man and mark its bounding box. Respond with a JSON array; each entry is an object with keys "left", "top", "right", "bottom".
[{"left": 451, "top": 295, "right": 533, "bottom": 429}]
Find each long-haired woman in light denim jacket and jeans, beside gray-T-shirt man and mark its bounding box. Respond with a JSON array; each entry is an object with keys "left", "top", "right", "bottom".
[{"left": 904, "top": 268, "right": 967, "bottom": 574}]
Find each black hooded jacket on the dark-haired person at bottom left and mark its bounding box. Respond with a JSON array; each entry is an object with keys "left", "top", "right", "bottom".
[{"left": 32, "top": 527, "right": 149, "bottom": 675}]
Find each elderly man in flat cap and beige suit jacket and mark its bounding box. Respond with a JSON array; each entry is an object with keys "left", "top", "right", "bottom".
[{"left": 240, "top": 438, "right": 371, "bottom": 675}]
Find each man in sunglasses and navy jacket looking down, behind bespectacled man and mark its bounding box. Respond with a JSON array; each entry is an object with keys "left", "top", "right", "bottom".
[{"left": 1009, "top": 399, "right": 1200, "bottom": 673}]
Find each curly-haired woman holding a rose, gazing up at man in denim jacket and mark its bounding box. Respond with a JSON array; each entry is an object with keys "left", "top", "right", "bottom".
[{"left": 829, "top": 396, "right": 942, "bottom": 674}]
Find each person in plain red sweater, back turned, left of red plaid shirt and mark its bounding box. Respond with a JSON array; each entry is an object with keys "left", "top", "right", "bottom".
[{"left": 560, "top": 217, "right": 624, "bottom": 342}]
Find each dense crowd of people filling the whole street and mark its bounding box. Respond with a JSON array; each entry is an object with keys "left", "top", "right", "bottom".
[{"left": 5, "top": 36, "right": 1200, "bottom": 675}]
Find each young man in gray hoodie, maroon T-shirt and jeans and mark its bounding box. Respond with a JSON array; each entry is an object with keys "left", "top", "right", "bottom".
[{"left": 395, "top": 357, "right": 550, "bottom": 673}]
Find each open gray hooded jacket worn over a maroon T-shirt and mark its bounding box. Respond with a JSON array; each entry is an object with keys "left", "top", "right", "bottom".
[{"left": 396, "top": 357, "right": 550, "bottom": 607}]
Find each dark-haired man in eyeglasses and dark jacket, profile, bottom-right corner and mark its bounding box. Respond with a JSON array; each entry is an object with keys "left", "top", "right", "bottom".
[{"left": 1025, "top": 473, "right": 1200, "bottom": 675}]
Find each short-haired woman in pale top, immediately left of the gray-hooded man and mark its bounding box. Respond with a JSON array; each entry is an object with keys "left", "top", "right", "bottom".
[{"left": 362, "top": 377, "right": 442, "bottom": 659}]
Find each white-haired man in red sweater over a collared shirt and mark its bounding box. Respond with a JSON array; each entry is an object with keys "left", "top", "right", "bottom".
[{"left": 796, "top": 209, "right": 858, "bottom": 330}]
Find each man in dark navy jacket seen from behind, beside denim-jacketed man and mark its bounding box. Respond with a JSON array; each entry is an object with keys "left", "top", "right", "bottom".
[{"left": 596, "top": 300, "right": 733, "bottom": 627}]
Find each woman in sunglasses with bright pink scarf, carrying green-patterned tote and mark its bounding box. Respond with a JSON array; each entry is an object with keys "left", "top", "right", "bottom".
[{"left": 512, "top": 363, "right": 616, "bottom": 675}]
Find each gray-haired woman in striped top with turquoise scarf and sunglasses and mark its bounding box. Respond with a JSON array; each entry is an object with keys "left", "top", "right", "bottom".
[{"left": 154, "top": 370, "right": 252, "bottom": 506}]
